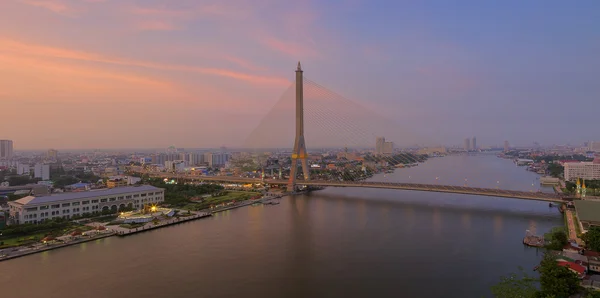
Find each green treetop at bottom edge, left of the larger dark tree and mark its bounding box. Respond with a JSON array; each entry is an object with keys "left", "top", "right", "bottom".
[{"left": 492, "top": 267, "right": 538, "bottom": 298}]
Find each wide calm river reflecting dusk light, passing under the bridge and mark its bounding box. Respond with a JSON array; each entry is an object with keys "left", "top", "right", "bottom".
[{"left": 0, "top": 155, "right": 563, "bottom": 298}]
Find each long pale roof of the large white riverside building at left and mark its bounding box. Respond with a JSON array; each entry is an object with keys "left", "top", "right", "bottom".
[{"left": 15, "top": 185, "right": 162, "bottom": 205}]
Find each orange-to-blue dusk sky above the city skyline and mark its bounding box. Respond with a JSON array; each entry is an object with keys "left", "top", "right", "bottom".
[{"left": 0, "top": 0, "right": 600, "bottom": 150}]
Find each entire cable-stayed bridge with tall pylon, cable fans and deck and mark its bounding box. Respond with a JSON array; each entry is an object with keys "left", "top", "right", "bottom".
[{"left": 141, "top": 62, "right": 564, "bottom": 202}]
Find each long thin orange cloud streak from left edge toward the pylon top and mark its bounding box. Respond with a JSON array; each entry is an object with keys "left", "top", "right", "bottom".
[{"left": 0, "top": 39, "right": 289, "bottom": 86}]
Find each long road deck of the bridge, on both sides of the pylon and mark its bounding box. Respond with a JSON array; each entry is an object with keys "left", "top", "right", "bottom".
[{"left": 151, "top": 173, "right": 566, "bottom": 203}]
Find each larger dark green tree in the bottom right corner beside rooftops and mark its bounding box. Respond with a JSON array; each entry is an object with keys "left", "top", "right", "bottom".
[{"left": 539, "top": 254, "right": 580, "bottom": 298}]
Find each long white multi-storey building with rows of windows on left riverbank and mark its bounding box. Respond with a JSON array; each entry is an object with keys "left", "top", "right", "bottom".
[{"left": 8, "top": 185, "right": 165, "bottom": 224}]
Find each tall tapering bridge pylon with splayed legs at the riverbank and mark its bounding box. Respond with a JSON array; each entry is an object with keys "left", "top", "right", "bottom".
[{"left": 287, "top": 62, "right": 310, "bottom": 191}]
